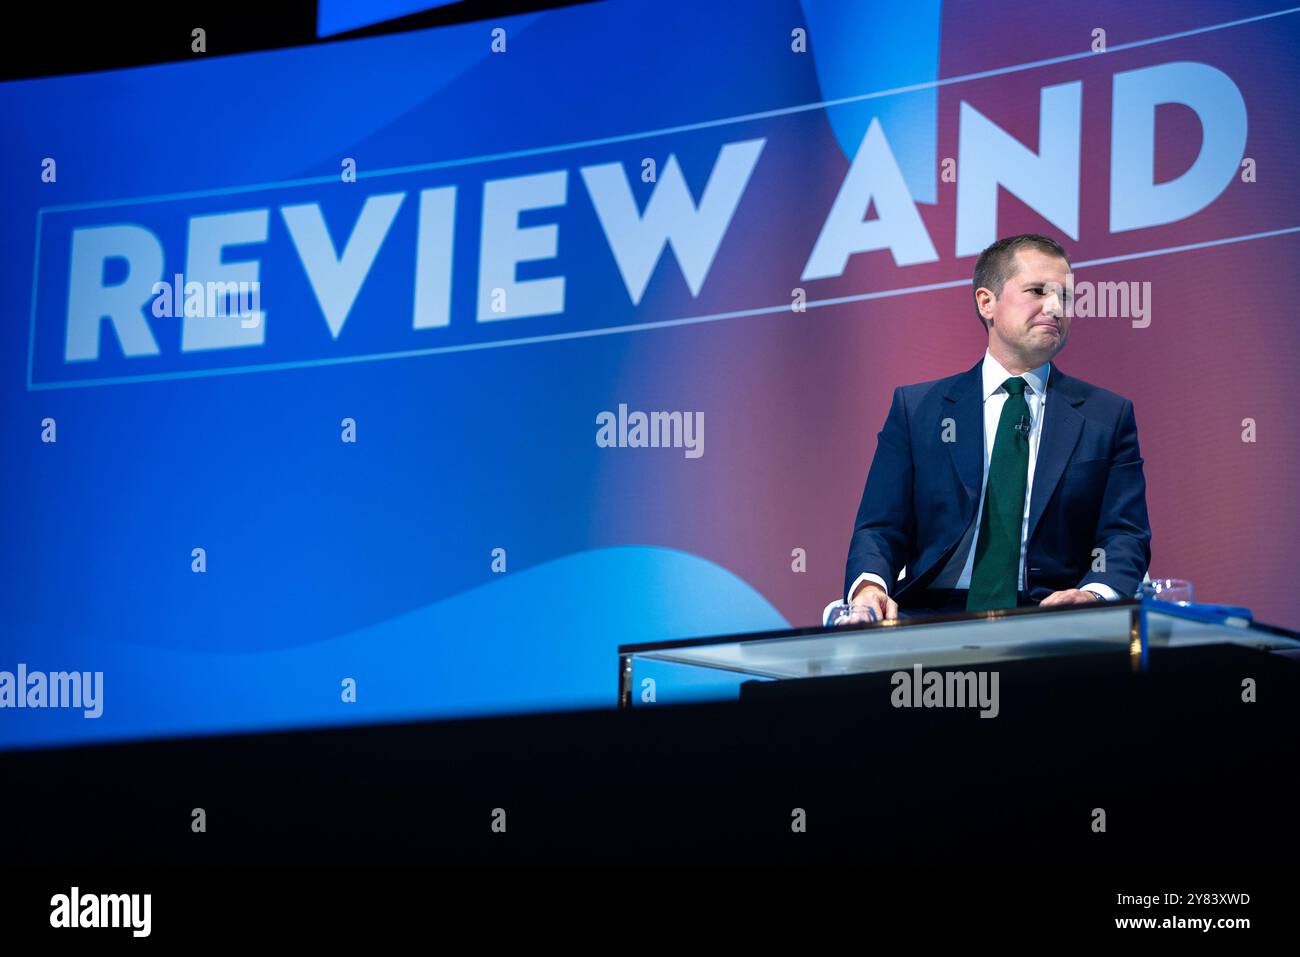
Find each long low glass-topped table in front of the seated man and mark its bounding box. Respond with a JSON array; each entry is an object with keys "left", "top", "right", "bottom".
[{"left": 619, "top": 599, "right": 1300, "bottom": 709}]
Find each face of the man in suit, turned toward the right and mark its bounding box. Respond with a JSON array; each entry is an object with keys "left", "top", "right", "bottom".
[{"left": 980, "top": 248, "right": 1070, "bottom": 365}]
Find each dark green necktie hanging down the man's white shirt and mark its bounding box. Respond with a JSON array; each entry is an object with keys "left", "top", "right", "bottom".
[{"left": 966, "top": 376, "right": 1030, "bottom": 611}]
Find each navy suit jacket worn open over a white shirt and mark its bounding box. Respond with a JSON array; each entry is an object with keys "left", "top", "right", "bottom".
[{"left": 845, "top": 358, "right": 1151, "bottom": 607}]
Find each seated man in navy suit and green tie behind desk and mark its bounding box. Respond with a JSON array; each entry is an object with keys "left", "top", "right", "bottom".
[{"left": 845, "top": 234, "right": 1151, "bottom": 619}]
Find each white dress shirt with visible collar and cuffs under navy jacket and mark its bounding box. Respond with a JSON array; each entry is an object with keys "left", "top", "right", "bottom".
[{"left": 849, "top": 351, "right": 1119, "bottom": 601}]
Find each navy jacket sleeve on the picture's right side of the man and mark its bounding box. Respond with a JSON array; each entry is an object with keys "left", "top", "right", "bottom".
[{"left": 1079, "top": 402, "right": 1151, "bottom": 598}]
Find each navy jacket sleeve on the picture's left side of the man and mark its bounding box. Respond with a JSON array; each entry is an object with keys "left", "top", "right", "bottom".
[{"left": 844, "top": 389, "right": 917, "bottom": 593}]
